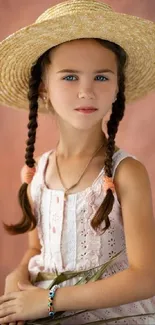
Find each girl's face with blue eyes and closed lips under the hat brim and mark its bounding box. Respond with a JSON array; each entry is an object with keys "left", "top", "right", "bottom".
[{"left": 45, "top": 39, "right": 118, "bottom": 130}]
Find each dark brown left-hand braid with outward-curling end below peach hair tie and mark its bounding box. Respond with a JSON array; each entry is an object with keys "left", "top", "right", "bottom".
[{"left": 3, "top": 57, "right": 42, "bottom": 234}]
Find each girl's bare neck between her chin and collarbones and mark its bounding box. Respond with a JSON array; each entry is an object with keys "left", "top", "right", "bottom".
[{"left": 56, "top": 120, "right": 107, "bottom": 159}]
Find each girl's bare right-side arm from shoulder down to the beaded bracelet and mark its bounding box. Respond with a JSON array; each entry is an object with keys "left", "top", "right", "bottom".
[{"left": 54, "top": 158, "right": 155, "bottom": 311}]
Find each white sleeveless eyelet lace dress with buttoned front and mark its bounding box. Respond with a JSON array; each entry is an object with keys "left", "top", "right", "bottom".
[{"left": 28, "top": 149, "right": 155, "bottom": 325}]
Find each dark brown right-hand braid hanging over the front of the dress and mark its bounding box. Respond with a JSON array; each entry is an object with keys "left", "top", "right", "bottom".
[{"left": 91, "top": 74, "right": 125, "bottom": 232}]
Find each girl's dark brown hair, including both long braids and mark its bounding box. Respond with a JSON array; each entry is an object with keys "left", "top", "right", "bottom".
[{"left": 4, "top": 39, "right": 128, "bottom": 235}]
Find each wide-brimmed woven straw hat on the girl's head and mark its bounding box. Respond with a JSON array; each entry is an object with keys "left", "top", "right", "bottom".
[{"left": 0, "top": 0, "right": 155, "bottom": 113}]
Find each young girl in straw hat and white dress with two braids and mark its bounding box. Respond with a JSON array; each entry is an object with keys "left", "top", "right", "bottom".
[{"left": 0, "top": 0, "right": 155, "bottom": 324}]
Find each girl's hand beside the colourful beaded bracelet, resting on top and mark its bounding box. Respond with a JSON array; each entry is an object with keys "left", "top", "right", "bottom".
[{"left": 0, "top": 283, "right": 49, "bottom": 324}]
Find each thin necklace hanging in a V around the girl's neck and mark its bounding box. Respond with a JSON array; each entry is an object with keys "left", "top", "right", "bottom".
[{"left": 55, "top": 143, "right": 104, "bottom": 201}]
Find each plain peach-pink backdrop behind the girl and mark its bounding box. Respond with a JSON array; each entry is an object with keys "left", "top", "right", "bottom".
[{"left": 0, "top": 0, "right": 155, "bottom": 294}]
